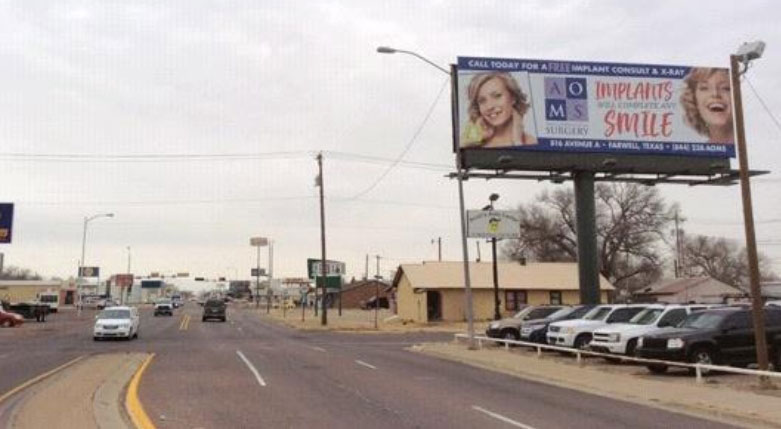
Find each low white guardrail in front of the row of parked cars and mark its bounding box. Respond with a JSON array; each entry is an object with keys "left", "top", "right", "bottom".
[{"left": 455, "top": 334, "right": 781, "bottom": 383}]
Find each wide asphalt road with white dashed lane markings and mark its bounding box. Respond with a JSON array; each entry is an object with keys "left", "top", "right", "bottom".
[{"left": 0, "top": 304, "right": 740, "bottom": 429}]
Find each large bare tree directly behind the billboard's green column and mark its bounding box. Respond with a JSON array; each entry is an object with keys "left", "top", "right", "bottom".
[{"left": 504, "top": 183, "right": 673, "bottom": 289}]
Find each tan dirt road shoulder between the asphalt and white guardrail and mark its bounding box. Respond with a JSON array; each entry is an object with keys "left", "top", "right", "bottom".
[{"left": 418, "top": 343, "right": 781, "bottom": 428}]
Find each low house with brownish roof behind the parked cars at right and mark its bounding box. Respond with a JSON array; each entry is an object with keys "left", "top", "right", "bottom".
[{"left": 634, "top": 277, "right": 745, "bottom": 304}]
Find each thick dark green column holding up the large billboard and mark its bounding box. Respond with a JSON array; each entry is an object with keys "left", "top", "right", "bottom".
[{"left": 574, "top": 171, "right": 600, "bottom": 304}]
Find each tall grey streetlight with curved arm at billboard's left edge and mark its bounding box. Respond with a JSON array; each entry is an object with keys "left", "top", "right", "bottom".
[{"left": 377, "top": 46, "right": 477, "bottom": 350}]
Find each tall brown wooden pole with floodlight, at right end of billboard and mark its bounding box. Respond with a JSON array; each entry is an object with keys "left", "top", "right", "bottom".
[{"left": 730, "top": 55, "right": 770, "bottom": 386}]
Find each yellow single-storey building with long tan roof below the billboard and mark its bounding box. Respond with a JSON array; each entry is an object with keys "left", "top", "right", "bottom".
[{"left": 393, "top": 262, "right": 614, "bottom": 323}]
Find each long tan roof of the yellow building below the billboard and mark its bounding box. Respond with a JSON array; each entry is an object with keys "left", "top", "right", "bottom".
[{"left": 393, "top": 261, "right": 614, "bottom": 290}]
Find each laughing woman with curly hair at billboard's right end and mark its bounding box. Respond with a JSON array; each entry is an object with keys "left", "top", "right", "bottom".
[{"left": 681, "top": 67, "right": 735, "bottom": 144}]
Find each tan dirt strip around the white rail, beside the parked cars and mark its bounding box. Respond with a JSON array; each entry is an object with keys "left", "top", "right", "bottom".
[{"left": 412, "top": 342, "right": 781, "bottom": 428}]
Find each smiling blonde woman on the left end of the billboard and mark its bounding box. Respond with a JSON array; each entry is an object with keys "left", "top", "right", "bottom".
[{"left": 461, "top": 72, "right": 537, "bottom": 148}]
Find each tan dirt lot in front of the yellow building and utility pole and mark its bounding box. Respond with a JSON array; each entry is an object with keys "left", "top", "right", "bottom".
[{"left": 257, "top": 308, "right": 487, "bottom": 333}]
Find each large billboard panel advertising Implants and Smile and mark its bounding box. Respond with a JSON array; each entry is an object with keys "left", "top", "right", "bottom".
[{"left": 456, "top": 57, "right": 735, "bottom": 158}]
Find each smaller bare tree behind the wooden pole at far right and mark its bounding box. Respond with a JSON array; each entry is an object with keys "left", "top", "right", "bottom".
[{"left": 683, "top": 235, "right": 777, "bottom": 290}]
